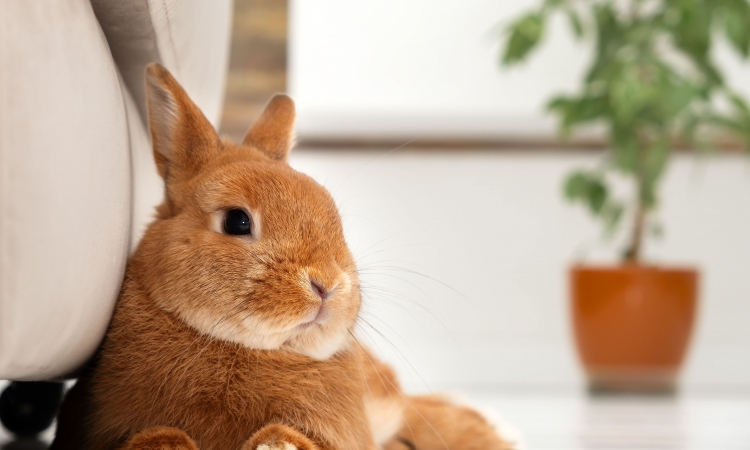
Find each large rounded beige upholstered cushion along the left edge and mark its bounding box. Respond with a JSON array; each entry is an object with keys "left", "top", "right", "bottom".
[{"left": 0, "top": 0, "right": 131, "bottom": 379}]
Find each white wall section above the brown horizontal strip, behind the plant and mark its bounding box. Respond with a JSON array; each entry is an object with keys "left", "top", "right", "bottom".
[{"left": 289, "top": 0, "right": 750, "bottom": 140}]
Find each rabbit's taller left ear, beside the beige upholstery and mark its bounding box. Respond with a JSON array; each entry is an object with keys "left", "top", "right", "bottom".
[{"left": 146, "top": 63, "right": 221, "bottom": 181}]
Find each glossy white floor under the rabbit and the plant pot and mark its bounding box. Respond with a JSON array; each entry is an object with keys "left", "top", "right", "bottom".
[{"left": 0, "top": 391, "right": 750, "bottom": 450}]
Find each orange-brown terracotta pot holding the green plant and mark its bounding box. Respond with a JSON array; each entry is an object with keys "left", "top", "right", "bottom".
[{"left": 570, "top": 265, "right": 698, "bottom": 392}]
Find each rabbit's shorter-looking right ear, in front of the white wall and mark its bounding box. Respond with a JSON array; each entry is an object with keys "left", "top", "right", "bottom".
[{"left": 242, "top": 94, "right": 295, "bottom": 161}]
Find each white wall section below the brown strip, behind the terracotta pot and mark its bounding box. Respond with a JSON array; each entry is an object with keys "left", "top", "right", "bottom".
[{"left": 292, "top": 150, "right": 750, "bottom": 390}]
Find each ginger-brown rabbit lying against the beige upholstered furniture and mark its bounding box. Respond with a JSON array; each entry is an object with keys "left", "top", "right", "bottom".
[{"left": 52, "top": 65, "right": 510, "bottom": 450}]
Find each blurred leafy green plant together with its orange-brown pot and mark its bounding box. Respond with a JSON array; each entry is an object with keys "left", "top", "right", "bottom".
[{"left": 502, "top": 0, "right": 750, "bottom": 391}]
